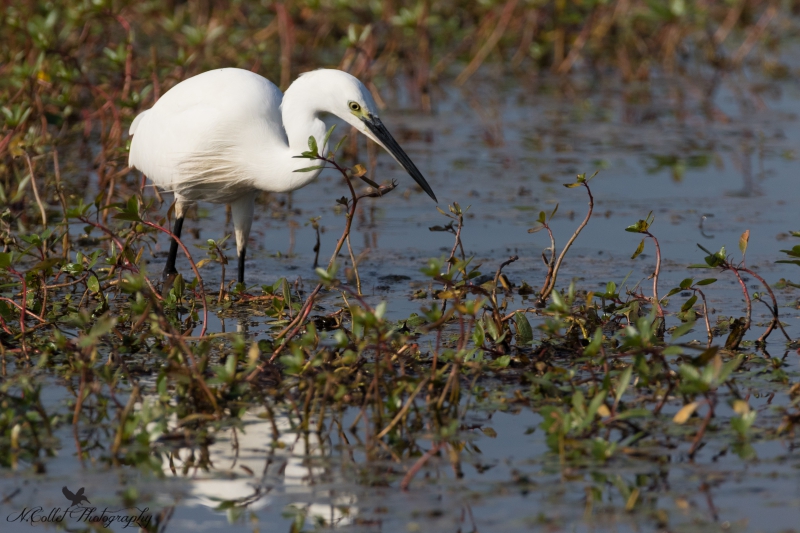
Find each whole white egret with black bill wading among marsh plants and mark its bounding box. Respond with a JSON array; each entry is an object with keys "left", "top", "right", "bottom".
[{"left": 129, "top": 68, "right": 436, "bottom": 283}]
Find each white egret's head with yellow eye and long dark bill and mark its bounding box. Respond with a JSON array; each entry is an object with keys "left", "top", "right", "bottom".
[{"left": 300, "top": 70, "right": 437, "bottom": 201}]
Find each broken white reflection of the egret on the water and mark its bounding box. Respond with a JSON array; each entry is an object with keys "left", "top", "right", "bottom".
[{"left": 156, "top": 411, "right": 358, "bottom": 527}]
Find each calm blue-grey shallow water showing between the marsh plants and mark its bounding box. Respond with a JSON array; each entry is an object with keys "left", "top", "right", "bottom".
[{"left": 0, "top": 67, "right": 800, "bottom": 532}]
